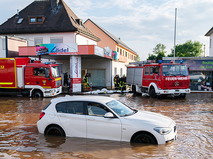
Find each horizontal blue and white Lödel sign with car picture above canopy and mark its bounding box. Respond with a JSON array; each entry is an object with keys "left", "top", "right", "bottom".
[{"left": 36, "top": 43, "right": 78, "bottom": 55}]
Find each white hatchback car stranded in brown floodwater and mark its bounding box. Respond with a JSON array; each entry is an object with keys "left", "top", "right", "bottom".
[{"left": 37, "top": 96, "right": 177, "bottom": 144}]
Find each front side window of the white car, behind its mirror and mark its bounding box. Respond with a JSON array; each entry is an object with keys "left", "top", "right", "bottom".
[{"left": 87, "top": 102, "right": 109, "bottom": 116}]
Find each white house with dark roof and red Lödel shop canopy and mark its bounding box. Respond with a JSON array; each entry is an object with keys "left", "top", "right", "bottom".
[{"left": 0, "top": 0, "right": 136, "bottom": 92}]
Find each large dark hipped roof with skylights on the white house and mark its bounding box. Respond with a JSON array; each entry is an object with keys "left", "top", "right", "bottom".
[{"left": 0, "top": 0, "right": 100, "bottom": 41}]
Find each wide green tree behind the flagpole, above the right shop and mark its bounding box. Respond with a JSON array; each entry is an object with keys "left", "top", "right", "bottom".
[{"left": 168, "top": 40, "right": 203, "bottom": 57}]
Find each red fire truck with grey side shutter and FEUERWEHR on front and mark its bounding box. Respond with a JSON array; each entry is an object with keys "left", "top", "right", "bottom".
[{"left": 126, "top": 61, "right": 190, "bottom": 98}]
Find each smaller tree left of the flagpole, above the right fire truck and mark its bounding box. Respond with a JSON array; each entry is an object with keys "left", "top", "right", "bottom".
[{"left": 147, "top": 43, "right": 166, "bottom": 62}]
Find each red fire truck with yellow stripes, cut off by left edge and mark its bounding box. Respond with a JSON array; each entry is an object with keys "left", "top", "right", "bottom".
[{"left": 0, "top": 58, "right": 62, "bottom": 97}]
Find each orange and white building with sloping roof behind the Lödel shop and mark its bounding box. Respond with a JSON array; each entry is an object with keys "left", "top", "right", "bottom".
[{"left": 84, "top": 19, "right": 137, "bottom": 77}]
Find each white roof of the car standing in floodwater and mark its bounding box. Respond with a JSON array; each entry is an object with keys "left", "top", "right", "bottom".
[{"left": 51, "top": 95, "right": 115, "bottom": 103}]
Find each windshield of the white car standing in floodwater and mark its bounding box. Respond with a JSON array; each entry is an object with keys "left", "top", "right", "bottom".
[{"left": 106, "top": 100, "right": 135, "bottom": 116}]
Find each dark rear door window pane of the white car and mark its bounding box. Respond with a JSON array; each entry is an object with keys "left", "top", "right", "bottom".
[{"left": 67, "top": 102, "right": 84, "bottom": 114}]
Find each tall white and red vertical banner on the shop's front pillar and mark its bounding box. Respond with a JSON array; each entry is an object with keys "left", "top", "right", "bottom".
[{"left": 70, "top": 56, "right": 81, "bottom": 92}]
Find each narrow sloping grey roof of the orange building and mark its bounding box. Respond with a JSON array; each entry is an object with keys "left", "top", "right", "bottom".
[{"left": 84, "top": 19, "right": 137, "bottom": 54}]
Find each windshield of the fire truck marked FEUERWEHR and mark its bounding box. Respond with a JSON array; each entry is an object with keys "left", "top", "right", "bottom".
[{"left": 162, "top": 65, "right": 188, "bottom": 76}]
